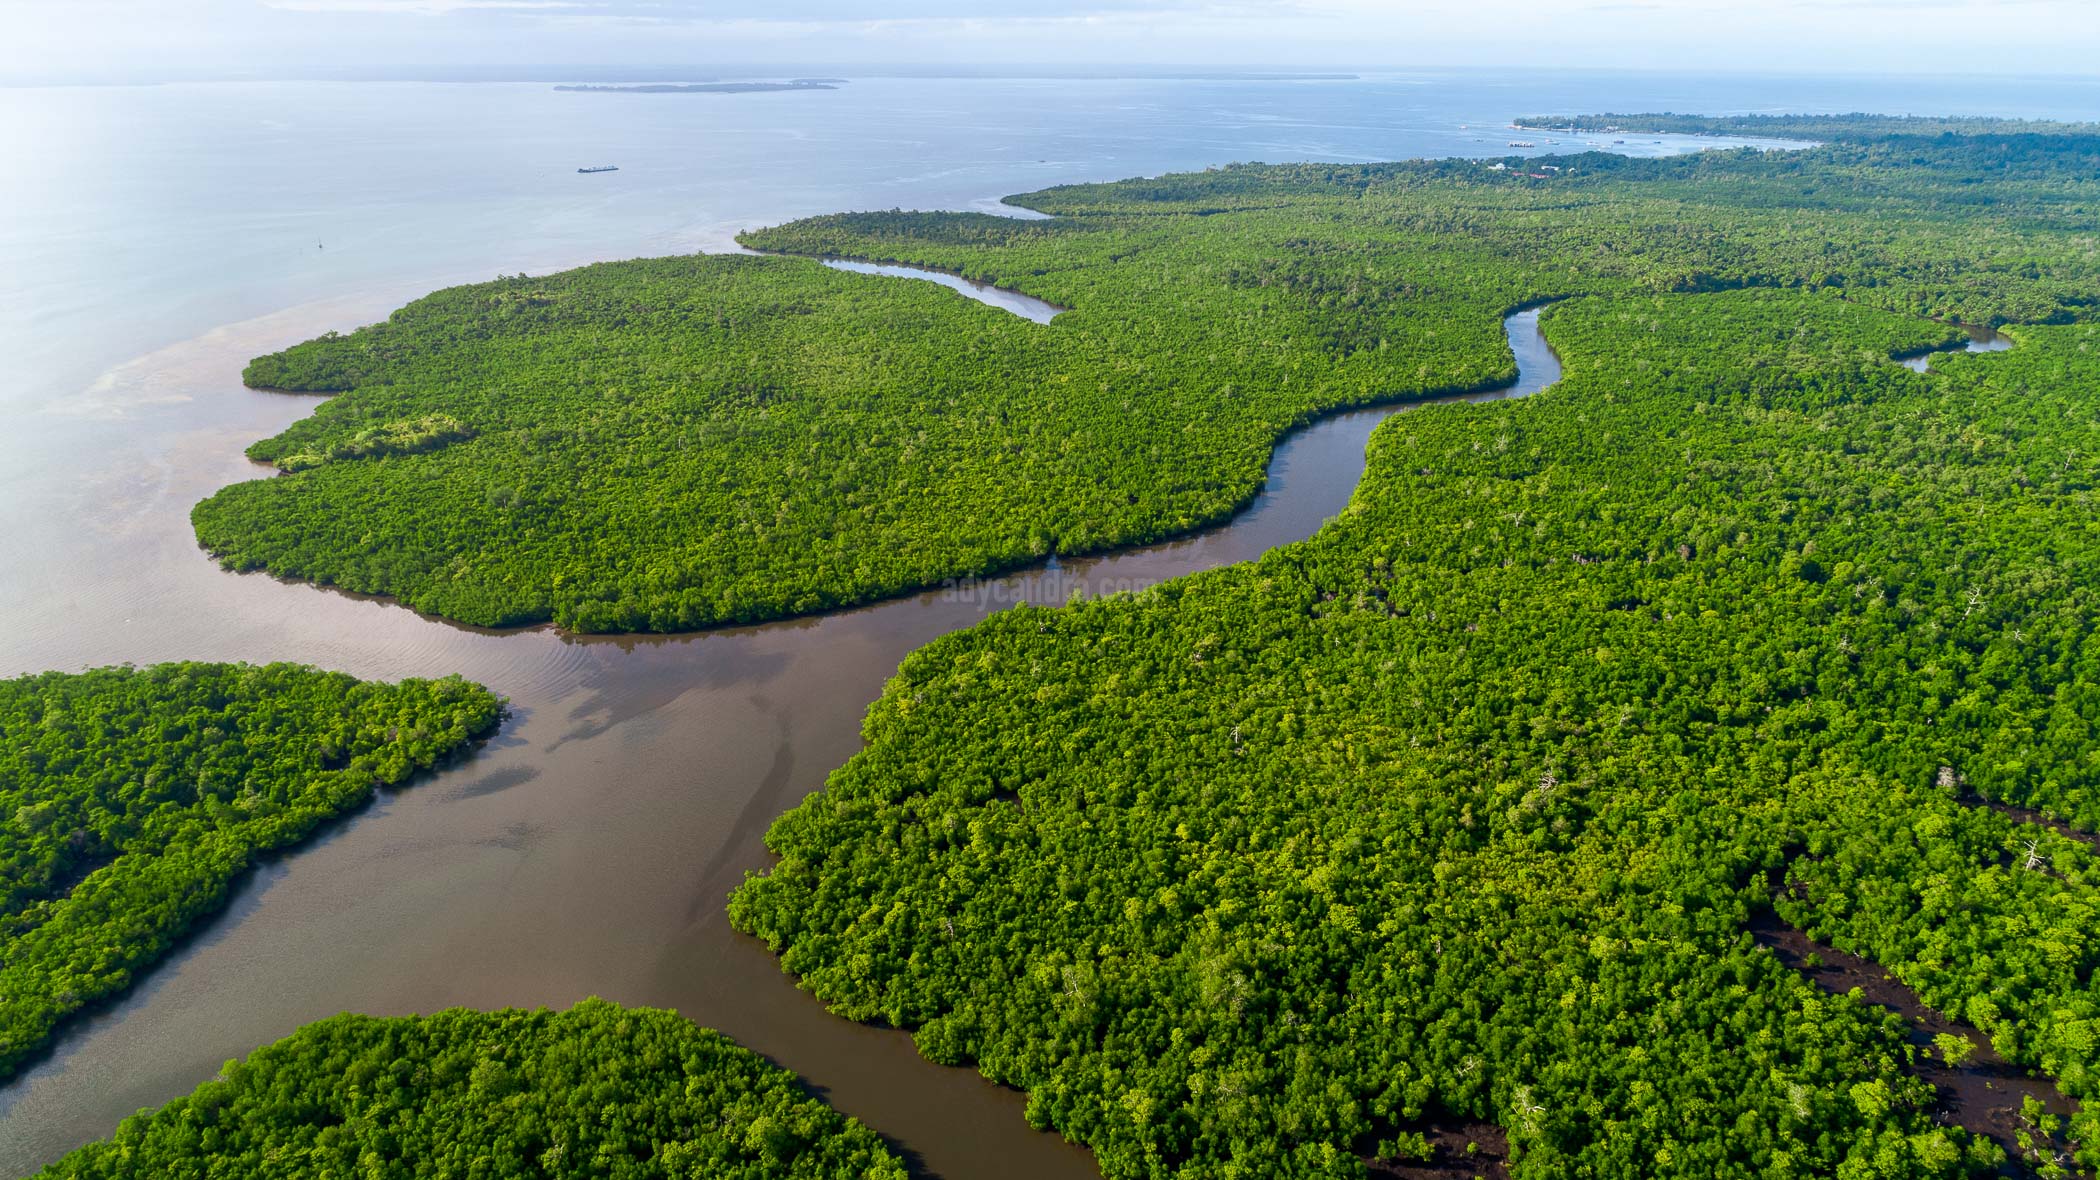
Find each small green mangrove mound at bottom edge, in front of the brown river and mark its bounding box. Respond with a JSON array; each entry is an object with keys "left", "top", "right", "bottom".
[{"left": 40, "top": 999, "right": 905, "bottom": 1180}]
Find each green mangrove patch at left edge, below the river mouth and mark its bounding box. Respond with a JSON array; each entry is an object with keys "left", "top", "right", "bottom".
[{"left": 0, "top": 663, "right": 502, "bottom": 1075}]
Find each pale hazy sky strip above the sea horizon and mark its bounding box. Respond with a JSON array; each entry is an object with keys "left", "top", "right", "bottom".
[{"left": 0, "top": 0, "right": 2100, "bottom": 80}]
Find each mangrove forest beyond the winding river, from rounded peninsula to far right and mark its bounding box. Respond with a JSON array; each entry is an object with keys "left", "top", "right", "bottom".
[{"left": 193, "top": 123, "right": 2100, "bottom": 630}]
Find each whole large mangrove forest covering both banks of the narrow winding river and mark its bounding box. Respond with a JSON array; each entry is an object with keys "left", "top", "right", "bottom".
[{"left": 148, "top": 115, "right": 2100, "bottom": 1180}]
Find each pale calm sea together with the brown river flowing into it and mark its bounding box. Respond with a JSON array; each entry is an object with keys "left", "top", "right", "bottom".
[{"left": 0, "top": 71, "right": 2100, "bottom": 1178}]
